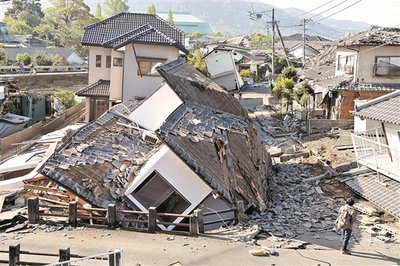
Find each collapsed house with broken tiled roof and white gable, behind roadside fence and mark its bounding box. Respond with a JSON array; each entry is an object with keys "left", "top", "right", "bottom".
[{"left": 40, "top": 59, "right": 271, "bottom": 230}]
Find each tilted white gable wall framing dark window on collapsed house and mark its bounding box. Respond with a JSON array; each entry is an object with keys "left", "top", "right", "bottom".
[{"left": 125, "top": 145, "right": 212, "bottom": 230}]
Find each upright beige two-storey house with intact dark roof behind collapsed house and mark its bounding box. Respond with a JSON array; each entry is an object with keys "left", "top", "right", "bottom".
[{"left": 77, "top": 13, "right": 187, "bottom": 121}]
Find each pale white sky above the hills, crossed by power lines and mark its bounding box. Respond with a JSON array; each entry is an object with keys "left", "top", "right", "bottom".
[{"left": 260, "top": 0, "right": 400, "bottom": 27}]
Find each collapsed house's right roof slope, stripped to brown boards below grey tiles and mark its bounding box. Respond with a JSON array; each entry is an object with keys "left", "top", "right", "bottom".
[{"left": 158, "top": 103, "right": 270, "bottom": 207}]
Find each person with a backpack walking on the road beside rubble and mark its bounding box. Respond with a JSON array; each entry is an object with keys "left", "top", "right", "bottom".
[{"left": 336, "top": 198, "right": 356, "bottom": 255}]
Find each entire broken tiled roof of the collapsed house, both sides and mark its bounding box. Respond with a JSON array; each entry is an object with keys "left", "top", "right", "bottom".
[{"left": 40, "top": 59, "right": 271, "bottom": 216}]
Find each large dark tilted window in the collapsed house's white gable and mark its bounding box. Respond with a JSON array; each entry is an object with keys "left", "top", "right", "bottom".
[{"left": 132, "top": 171, "right": 190, "bottom": 222}]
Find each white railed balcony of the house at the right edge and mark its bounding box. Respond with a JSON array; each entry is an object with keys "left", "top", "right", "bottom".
[{"left": 351, "top": 128, "right": 400, "bottom": 182}]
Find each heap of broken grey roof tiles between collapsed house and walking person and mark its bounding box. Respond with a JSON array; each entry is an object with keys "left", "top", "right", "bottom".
[{"left": 245, "top": 160, "right": 343, "bottom": 238}]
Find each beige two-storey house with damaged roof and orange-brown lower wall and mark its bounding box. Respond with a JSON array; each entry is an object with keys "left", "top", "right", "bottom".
[{"left": 302, "top": 28, "right": 400, "bottom": 120}]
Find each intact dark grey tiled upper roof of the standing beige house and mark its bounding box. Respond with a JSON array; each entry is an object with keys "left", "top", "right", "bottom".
[{"left": 81, "top": 13, "right": 186, "bottom": 52}]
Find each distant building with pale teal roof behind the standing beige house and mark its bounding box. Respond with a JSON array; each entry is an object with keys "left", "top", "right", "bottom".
[{"left": 157, "top": 12, "right": 213, "bottom": 34}]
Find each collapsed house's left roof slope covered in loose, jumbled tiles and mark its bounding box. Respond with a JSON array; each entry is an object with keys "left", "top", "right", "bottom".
[{"left": 39, "top": 101, "right": 161, "bottom": 208}]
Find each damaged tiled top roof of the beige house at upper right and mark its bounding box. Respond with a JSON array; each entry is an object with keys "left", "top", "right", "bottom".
[{"left": 338, "top": 27, "right": 400, "bottom": 46}]
